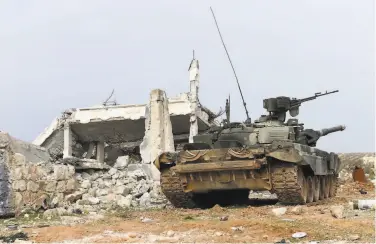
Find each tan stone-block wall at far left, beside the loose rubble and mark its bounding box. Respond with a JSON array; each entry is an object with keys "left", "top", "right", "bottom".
[{"left": 0, "top": 133, "right": 76, "bottom": 216}]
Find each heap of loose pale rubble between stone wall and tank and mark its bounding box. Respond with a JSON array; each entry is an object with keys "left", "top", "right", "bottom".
[{"left": 65, "top": 156, "right": 168, "bottom": 212}]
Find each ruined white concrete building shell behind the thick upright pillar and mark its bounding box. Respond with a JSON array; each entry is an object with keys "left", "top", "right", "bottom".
[{"left": 33, "top": 59, "right": 218, "bottom": 168}]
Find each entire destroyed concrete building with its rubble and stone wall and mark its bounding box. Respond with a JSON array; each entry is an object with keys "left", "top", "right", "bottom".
[{"left": 0, "top": 59, "right": 218, "bottom": 216}]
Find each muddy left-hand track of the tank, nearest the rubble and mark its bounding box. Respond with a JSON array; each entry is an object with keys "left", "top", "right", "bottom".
[{"left": 161, "top": 169, "right": 198, "bottom": 208}]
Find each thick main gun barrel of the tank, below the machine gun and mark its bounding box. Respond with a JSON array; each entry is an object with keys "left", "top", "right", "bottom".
[{"left": 297, "top": 125, "right": 346, "bottom": 147}]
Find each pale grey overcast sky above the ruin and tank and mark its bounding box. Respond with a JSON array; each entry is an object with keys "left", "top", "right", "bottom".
[{"left": 0, "top": 0, "right": 375, "bottom": 152}]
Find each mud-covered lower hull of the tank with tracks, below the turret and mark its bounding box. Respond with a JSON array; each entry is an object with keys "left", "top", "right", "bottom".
[{"left": 154, "top": 142, "right": 340, "bottom": 208}]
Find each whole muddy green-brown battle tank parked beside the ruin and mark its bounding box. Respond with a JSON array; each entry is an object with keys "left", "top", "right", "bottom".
[{"left": 154, "top": 90, "right": 345, "bottom": 208}]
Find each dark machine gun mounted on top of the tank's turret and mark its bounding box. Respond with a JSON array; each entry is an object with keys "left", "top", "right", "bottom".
[{"left": 263, "top": 90, "right": 338, "bottom": 122}]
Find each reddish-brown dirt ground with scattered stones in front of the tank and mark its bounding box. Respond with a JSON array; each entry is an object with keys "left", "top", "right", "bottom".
[{"left": 0, "top": 183, "right": 375, "bottom": 243}]
